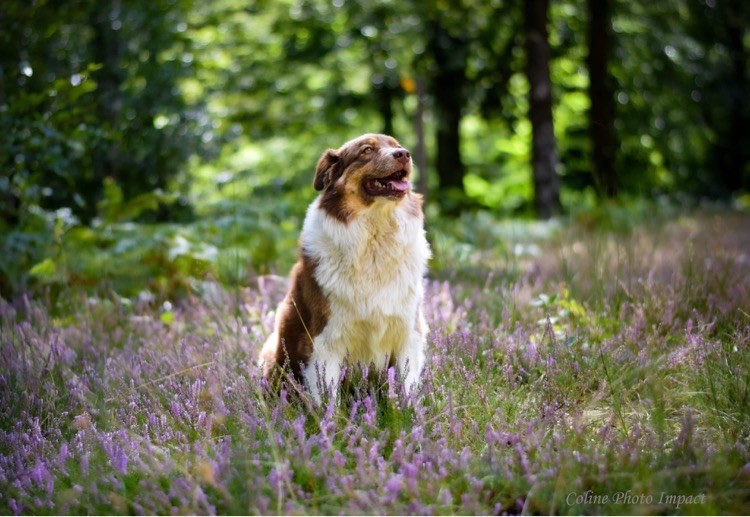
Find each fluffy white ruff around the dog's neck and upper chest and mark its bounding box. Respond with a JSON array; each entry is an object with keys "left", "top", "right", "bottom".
[{"left": 301, "top": 194, "right": 430, "bottom": 319}]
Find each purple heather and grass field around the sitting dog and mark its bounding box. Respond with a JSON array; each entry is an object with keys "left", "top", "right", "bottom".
[{"left": 0, "top": 211, "right": 750, "bottom": 514}]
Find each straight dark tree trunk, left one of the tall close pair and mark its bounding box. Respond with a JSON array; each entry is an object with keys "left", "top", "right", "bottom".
[{"left": 524, "top": 0, "right": 560, "bottom": 219}]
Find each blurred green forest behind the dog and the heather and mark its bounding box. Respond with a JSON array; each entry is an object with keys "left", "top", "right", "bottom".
[{"left": 0, "top": 0, "right": 750, "bottom": 297}]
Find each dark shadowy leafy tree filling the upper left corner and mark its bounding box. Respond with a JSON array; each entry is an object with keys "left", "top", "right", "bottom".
[{"left": 0, "top": 0, "right": 200, "bottom": 222}]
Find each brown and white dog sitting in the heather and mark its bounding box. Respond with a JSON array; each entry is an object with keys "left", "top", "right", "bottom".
[{"left": 260, "top": 134, "right": 430, "bottom": 402}]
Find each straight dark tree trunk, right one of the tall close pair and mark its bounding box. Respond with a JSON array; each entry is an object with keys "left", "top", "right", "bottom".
[{"left": 586, "top": 0, "right": 617, "bottom": 198}]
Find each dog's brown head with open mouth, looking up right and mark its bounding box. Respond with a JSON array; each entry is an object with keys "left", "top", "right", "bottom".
[{"left": 313, "top": 134, "right": 412, "bottom": 221}]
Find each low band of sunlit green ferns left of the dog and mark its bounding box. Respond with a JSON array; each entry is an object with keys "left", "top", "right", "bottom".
[{"left": 9, "top": 180, "right": 301, "bottom": 299}]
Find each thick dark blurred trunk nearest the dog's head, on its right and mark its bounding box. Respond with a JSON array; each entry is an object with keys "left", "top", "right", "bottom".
[{"left": 430, "top": 22, "right": 468, "bottom": 196}]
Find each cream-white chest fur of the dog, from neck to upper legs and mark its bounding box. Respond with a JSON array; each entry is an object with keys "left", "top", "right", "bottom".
[{"left": 302, "top": 196, "right": 430, "bottom": 366}]
